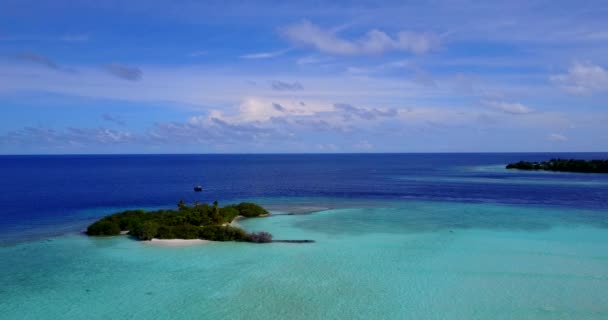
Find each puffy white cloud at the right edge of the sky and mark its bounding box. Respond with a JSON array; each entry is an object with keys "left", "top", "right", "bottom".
[{"left": 550, "top": 62, "right": 608, "bottom": 94}]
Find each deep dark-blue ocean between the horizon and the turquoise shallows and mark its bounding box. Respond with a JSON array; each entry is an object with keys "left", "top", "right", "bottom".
[{"left": 0, "top": 153, "right": 608, "bottom": 243}]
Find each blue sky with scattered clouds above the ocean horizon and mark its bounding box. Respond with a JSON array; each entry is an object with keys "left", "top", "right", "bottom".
[{"left": 0, "top": 0, "right": 608, "bottom": 154}]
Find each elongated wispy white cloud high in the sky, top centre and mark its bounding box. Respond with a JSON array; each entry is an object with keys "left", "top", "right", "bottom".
[{"left": 281, "top": 21, "right": 440, "bottom": 55}]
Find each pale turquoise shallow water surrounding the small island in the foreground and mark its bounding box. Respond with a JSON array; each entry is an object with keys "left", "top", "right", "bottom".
[{"left": 0, "top": 202, "right": 608, "bottom": 319}]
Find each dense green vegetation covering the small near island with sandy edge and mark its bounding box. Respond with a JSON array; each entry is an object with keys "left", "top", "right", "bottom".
[{"left": 87, "top": 201, "right": 272, "bottom": 243}]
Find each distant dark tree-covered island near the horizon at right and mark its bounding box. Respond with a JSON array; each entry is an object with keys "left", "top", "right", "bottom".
[{"left": 506, "top": 159, "right": 608, "bottom": 173}]
